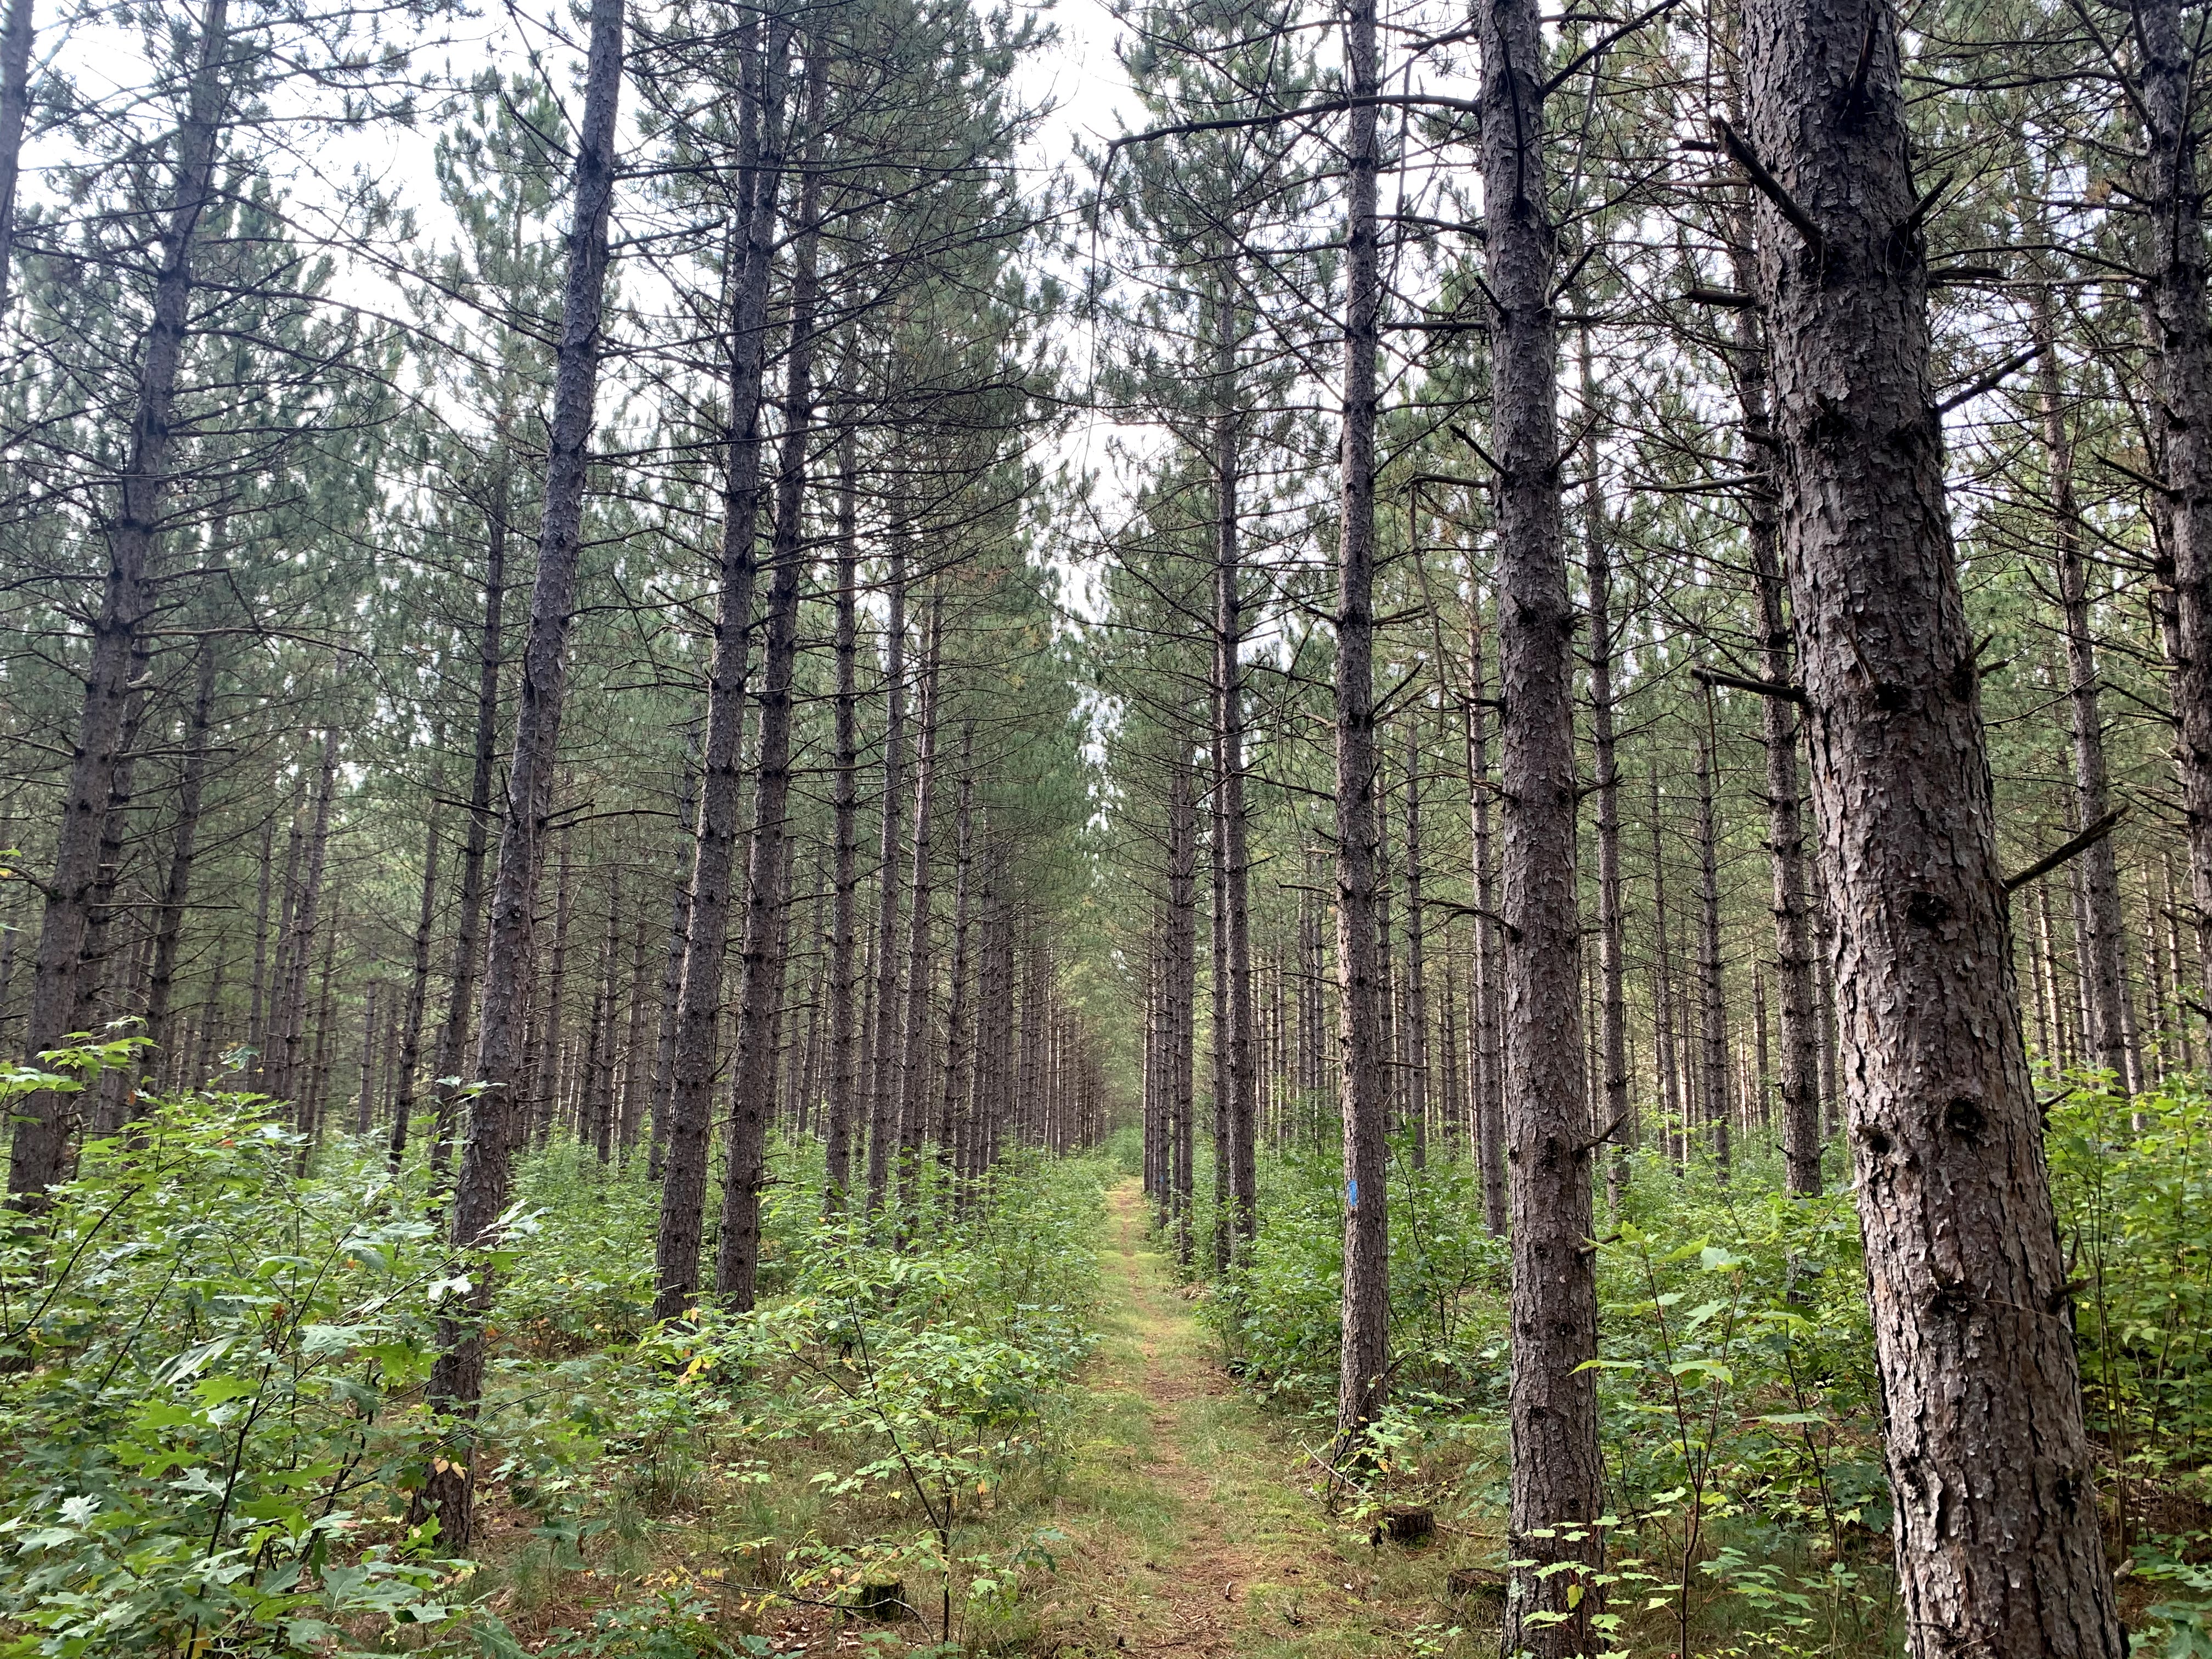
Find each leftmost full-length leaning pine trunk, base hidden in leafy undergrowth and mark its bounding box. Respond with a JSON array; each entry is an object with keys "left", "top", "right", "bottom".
[{"left": 0, "top": 0, "right": 230, "bottom": 1212}]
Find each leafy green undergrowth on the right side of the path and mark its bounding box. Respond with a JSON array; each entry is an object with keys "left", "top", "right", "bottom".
[{"left": 1192, "top": 1080, "right": 2212, "bottom": 1659}]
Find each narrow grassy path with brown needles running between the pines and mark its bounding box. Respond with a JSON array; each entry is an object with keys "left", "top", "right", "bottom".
[{"left": 1004, "top": 1181, "right": 1496, "bottom": 1659}]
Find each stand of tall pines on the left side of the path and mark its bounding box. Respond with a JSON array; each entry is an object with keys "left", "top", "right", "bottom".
[{"left": 0, "top": 0, "right": 1141, "bottom": 1575}]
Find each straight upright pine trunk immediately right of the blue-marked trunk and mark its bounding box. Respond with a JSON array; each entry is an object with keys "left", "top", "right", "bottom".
[{"left": 1480, "top": 0, "right": 1604, "bottom": 1659}]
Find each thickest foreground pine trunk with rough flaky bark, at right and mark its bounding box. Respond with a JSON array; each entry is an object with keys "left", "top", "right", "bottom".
[{"left": 1743, "top": 0, "right": 2123, "bottom": 1659}]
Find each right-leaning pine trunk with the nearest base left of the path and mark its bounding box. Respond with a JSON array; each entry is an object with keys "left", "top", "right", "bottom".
[{"left": 416, "top": 0, "right": 624, "bottom": 1555}]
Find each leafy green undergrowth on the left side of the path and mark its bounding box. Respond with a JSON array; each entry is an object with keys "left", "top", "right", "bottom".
[{"left": 0, "top": 1048, "right": 1104, "bottom": 1659}]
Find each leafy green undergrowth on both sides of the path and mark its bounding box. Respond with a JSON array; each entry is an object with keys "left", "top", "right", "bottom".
[{"left": 0, "top": 1040, "right": 2212, "bottom": 1659}]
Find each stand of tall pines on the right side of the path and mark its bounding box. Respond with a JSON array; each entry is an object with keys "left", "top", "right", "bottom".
[{"left": 1091, "top": 2, "right": 2212, "bottom": 1652}]
